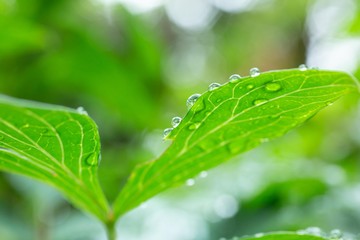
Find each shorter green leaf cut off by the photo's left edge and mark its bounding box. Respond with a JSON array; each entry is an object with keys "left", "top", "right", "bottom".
[{"left": 0, "top": 95, "right": 109, "bottom": 221}]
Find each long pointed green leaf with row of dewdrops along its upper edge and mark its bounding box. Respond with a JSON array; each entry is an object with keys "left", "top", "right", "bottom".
[{"left": 114, "top": 69, "right": 358, "bottom": 217}]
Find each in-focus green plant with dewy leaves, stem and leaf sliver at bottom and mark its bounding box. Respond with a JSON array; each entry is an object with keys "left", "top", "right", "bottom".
[{"left": 0, "top": 66, "right": 359, "bottom": 240}]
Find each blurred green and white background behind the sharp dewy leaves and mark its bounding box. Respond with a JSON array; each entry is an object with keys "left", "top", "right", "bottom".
[{"left": 0, "top": 0, "right": 360, "bottom": 240}]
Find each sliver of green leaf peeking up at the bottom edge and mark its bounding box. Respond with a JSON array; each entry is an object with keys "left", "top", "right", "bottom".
[{"left": 231, "top": 232, "right": 326, "bottom": 240}]
